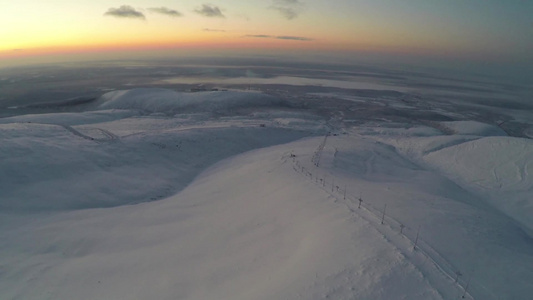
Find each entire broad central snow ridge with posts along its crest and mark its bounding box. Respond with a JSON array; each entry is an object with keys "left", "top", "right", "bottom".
[{"left": 0, "top": 137, "right": 533, "bottom": 299}]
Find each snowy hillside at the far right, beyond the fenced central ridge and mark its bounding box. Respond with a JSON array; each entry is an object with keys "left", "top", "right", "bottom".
[{"left": 372, "top": 123, "right": 533, "bottom": 233}]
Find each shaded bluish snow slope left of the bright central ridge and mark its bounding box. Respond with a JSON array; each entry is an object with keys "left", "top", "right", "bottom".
[{"left": 0, "top": 118, "right": 304, "bottom": 210}]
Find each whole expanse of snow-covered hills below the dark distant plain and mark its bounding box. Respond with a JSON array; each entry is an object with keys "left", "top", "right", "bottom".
[{"left": 0, "top": 89, "right": 533, "bottom": 299}]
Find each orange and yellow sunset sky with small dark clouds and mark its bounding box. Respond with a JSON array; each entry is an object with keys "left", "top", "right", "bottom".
[{"left": 0, "top": 0, "right": 533, "bottom": 71}]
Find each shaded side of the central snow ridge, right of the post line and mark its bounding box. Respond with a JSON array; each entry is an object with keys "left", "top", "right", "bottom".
[{"left": 295, "top": 137, "right": 533, "bottom": 299}]
